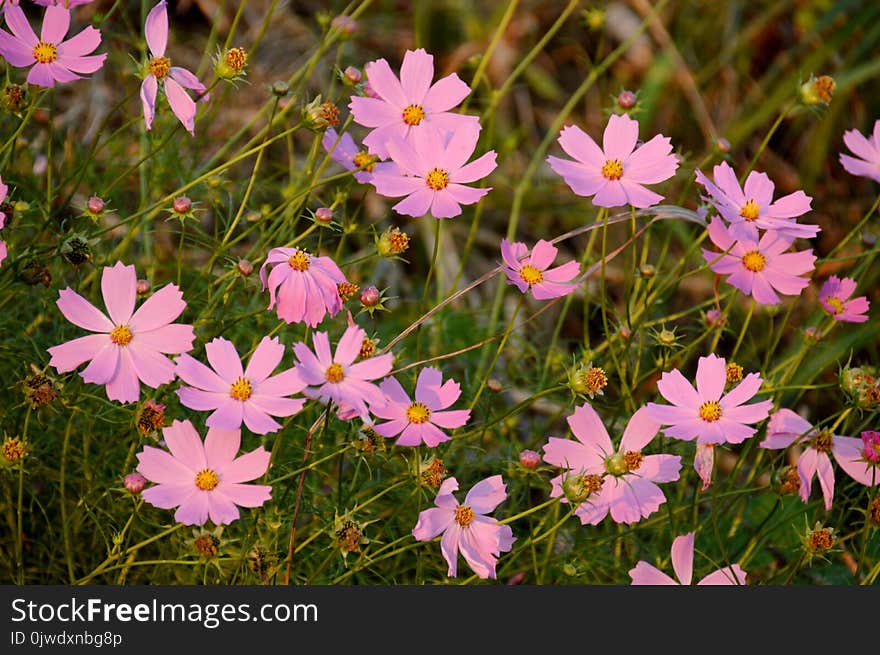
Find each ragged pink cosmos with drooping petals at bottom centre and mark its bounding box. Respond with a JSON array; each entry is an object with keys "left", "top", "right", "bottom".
[{"left": 412, "top": 475, "right": 516, "bottom": 579}]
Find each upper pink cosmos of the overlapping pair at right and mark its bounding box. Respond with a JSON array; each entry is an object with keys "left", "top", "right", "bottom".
[{"left": 697, "top": 162, "right": 820, "bottom": 241}]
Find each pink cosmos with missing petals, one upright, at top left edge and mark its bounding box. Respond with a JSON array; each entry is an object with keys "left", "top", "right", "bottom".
[{"left": 141, "top": 0, "right": 210, "bottom": 134}]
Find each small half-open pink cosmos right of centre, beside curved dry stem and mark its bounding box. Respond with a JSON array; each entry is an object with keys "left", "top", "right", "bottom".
[{"left": 501, "top": 239, "right": 580, "bottom": 300}]
